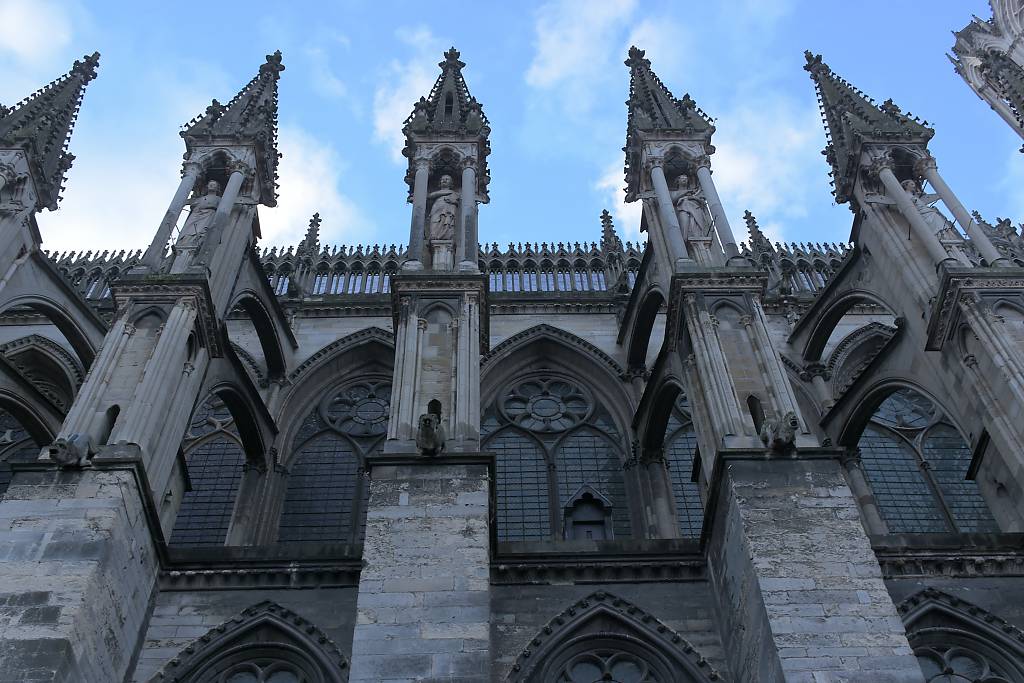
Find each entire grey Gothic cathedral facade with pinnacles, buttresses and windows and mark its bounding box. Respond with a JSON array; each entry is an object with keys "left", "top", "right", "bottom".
[{"left": 0, "top": 0, "right": 1024, "bottom": 683}]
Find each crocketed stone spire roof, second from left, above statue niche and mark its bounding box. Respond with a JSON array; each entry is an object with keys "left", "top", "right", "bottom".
[{"left": 181, "top": 50, "right": 285, "bottom": 207}]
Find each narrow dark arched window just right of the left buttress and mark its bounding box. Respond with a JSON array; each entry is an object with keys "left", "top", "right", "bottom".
[{"left": 171, "top": 397, "right": 245, "bottom": 546}]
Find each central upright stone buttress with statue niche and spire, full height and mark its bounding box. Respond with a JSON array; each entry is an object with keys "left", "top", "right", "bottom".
[{"left": 351, "top": 47, "right": 493, "bottom": 681}]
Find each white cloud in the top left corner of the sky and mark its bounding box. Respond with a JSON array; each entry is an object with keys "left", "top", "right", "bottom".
[{"left": 0, "top": 0, "right": 72, "bottom": 63}]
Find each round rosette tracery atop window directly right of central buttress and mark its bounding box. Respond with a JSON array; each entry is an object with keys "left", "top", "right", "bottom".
[{"left": 502, "top": 377, "right": 591, "bottom": 432}]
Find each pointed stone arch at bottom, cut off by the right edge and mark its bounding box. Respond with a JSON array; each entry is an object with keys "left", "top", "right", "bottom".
[{"left": 897, "top": 587, "right": 1024, "bottom": 683}]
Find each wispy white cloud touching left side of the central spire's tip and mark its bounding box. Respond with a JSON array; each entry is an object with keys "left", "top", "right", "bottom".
[{"left": 374, "top": 27, "right": 444, "bottom": 162}]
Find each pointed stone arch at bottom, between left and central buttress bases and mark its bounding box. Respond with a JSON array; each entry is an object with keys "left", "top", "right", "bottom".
[{"left": 150, "top": 601, "right": 349, "bottom": 683}]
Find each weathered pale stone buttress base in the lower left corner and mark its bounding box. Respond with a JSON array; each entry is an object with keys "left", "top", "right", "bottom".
[{"left": 0, "top": 470, "right": 157, "bottom": 683}]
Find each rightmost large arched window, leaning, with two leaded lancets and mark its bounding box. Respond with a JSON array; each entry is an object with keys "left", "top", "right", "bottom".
[{"left": 857, "top": 388, "right": 998, "bottom": 533}]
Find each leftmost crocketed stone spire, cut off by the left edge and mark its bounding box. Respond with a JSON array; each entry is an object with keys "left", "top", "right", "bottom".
[{"left": 0, "top": 52, "right": 99, "bottom": 211}]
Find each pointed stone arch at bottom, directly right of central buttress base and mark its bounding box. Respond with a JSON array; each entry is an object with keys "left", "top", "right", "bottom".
[{"left": 505, "top": 591, "right": 719, "bottom": 683}]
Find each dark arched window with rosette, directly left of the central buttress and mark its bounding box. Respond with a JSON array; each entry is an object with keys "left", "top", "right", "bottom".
[{"left": 278, "top": 378, "right": 391, "bottom": 543}]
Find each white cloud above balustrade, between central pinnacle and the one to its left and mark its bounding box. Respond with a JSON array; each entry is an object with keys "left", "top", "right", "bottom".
[{"left": 260, "top": 126, "right": 373, "bottom": 245}]
